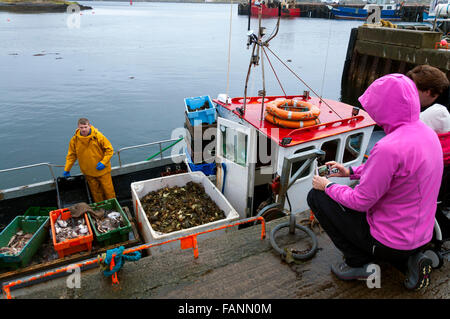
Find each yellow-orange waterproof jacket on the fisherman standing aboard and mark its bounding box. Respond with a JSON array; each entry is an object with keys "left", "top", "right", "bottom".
[{"left": 64, "top": 125, "right": 114, "bottom": 176}]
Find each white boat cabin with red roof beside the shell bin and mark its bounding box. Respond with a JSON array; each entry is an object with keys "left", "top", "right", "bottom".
[{"left": 214, "top": 92, "right": 375, "bottom": 218}]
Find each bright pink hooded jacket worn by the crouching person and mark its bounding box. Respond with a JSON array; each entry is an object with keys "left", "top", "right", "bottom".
[{"left": 326, "top": 74, "right": 443, "bottom": 250}]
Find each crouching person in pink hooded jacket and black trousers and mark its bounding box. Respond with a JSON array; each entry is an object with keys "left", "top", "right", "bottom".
[{"left": 308, "top": 74, "right": 443, "bottom": 289}]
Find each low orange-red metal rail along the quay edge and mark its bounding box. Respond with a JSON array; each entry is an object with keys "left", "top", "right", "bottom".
[{"left": 2, "top": 216, "right": 266, "bottom": 299}]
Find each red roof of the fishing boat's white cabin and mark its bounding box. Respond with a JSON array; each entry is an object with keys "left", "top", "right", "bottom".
[{"left": 214, "top": 95, "right": 376, "bottom": 147}]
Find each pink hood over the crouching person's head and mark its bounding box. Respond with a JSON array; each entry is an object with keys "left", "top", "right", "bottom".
[{"left": 358, "top": 73, "right": 420, "bottom": 134}]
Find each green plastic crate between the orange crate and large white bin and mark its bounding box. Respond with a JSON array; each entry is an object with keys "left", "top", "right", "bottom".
[{"left": 88, "top": 198, "right": 131, "bottom": 246}]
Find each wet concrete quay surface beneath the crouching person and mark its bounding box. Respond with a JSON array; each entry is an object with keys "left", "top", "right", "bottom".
[{"left": 7, "top": 218, "right": 450, "bottom": 299}]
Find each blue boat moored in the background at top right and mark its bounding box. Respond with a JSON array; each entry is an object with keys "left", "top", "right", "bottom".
[{"left": 331, "top": 0, "right": 401, "bottom": 21}]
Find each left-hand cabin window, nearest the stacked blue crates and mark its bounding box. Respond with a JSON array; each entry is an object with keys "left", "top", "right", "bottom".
[{"left": 220, "top": 125, "right": 248, "bottom": 166}]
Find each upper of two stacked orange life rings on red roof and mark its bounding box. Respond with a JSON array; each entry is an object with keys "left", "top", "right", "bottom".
[{"left": 266, "top": 99, "right": 320, "bottom": 121}]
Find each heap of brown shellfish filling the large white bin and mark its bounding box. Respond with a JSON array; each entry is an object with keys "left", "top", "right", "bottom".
[{"left": 141, "top": 182, "right": 226, "bottom": 233}]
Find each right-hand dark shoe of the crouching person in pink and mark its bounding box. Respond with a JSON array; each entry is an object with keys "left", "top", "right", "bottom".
[{"left": 405, "top": 252, "right": 433, "bottom": 290}]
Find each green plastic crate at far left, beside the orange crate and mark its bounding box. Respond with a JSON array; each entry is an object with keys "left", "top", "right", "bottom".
[{"left": 0, "top": 216, "right": 49, "bottom": 269}]
